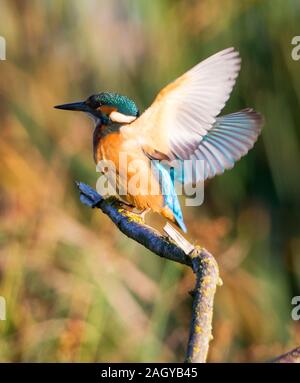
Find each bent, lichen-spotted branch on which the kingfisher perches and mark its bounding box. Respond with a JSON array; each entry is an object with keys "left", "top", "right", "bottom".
[{"left": 76, "top": 182, "right": 220, "bottom": 363}]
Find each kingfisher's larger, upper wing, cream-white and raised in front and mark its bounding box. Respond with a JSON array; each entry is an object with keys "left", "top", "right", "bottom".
[{"left": 122, "top": 48, "right": 241, "bottom": 160}]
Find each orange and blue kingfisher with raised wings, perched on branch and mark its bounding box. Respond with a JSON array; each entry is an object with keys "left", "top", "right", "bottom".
[{"left": 55, "top": 47, "right": 263, "bottom": 232}]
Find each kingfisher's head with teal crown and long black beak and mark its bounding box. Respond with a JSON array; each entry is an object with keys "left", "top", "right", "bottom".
[{"left": 55, "top": 92, "right": 139, "bottom": 124}]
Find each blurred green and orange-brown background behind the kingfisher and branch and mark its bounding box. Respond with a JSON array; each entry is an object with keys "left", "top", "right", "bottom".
[{"left": 0, "top": 0, "right": 300, "bottom": 362}]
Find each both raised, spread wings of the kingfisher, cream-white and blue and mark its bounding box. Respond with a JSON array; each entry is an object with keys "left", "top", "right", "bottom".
[{"left": 122, "top": 48, "right": 261, "bottom": 182}]
